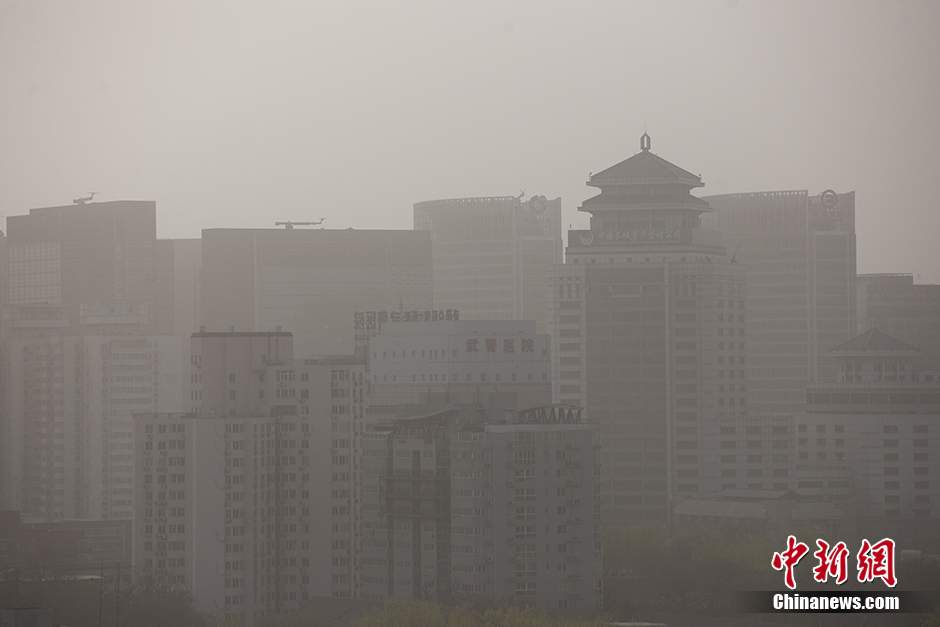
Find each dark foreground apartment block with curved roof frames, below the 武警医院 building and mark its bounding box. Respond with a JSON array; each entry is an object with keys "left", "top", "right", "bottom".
[{"left": 362, "top": 406, "right": 603, "bottom": 608}]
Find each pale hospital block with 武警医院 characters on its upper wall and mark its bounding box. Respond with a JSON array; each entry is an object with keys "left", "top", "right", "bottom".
[{"left": 368, "top": 320, "right": 551, "bottom": 410}]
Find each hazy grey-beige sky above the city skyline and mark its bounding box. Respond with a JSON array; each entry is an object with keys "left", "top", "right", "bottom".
[{"left": 0, "top": 0, "right": 940, "bottom": 283}]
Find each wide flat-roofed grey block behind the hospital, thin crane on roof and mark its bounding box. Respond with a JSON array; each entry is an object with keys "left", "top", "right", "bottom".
[{"left": 200, "top": 228, "right": 431, "bottom": 357}]
